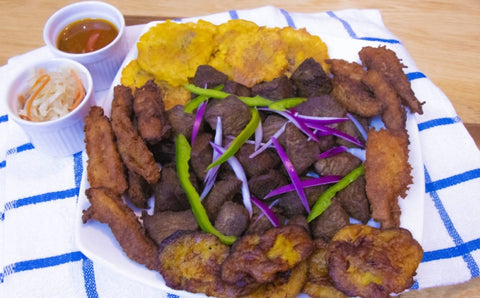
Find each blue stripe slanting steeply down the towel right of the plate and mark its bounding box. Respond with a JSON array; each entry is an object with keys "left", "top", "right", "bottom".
[{"left": 425, "top": 167, "right": 479, "bottom": 277}]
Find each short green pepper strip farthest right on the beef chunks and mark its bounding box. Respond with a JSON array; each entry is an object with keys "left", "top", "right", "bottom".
[{"left": 307, "top": 164, "right": 365, "bottom": 222}]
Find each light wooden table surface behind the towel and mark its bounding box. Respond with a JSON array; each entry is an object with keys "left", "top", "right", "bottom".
[{"left": 0, "top": 0, "right": 480, "bottom": 289}]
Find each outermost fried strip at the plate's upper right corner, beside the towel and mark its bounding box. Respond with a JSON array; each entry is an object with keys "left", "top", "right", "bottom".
[{"left": 358, "top": 46, "right": 425, "bottom": 114}]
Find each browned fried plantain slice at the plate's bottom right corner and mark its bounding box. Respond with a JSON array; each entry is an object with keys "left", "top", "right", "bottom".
[{"left": 327, "top": 225, "right": 423, "bottom": 297}]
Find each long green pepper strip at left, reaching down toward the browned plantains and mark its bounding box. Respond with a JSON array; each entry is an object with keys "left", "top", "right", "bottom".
[{"left": 175, "top": 134, "right": 237, "bottom": 245}]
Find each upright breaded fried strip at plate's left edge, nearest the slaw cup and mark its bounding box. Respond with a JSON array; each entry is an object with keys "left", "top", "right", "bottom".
[{"left": 84, "top": 106, "right": 128, "bottom": 194}]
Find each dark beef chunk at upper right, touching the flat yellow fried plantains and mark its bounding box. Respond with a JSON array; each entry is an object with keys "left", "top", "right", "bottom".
[{"left": 291, "top": 58, "right": 333, "bottom": 97}]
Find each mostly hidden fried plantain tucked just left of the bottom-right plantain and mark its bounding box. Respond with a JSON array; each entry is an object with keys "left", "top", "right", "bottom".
[{"left": 302, "top": 239, "right": 346, "bottom": 298}]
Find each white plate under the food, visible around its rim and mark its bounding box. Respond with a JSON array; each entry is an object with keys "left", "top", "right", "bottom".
[{"left": 75, "top": 22, "right": 425, "bottom": 297}]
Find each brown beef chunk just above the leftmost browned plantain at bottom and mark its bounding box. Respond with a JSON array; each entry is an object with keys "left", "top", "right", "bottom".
[{"left": 142, "top": 209, "right": 198, "bottom": 245}]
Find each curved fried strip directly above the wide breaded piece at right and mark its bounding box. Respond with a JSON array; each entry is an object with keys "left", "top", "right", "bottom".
[{"left": 363, "top": 69, "right": 407, "bottom": 130}]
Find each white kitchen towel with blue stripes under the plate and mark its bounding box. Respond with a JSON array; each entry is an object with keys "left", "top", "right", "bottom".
[{"left": 0, "top": 6, "right": 480, "bottom": 297}]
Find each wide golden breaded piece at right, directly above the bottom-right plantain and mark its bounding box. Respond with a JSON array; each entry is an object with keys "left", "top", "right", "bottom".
[{"left": 365, "top": 129, "right": 412, "bottom": 228}]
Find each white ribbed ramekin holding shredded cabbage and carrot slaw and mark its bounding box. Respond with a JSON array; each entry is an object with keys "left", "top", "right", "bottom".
[{"left": 5, "top": 58, "right": 95, "bottom": 157}]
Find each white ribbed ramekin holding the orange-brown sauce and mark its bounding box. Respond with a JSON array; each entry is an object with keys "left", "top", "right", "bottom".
[{"left": 43, "top": 1, "right": 128, "bottom": 91}]
